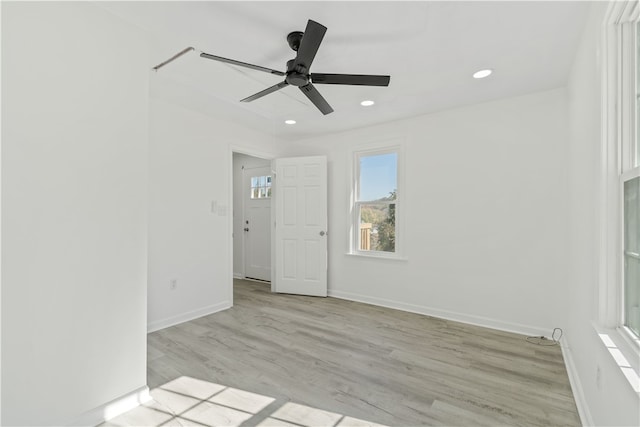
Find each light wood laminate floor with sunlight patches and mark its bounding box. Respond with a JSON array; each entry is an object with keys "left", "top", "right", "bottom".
[{"left": 105, "top": 280, "right": 580, "bottom": 426}]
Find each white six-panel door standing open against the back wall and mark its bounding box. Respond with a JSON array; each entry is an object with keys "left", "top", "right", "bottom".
[{"left": 272, "top": 156, "right": 327, "bottom": 297}]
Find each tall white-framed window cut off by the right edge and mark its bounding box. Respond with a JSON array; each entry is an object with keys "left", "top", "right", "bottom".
[{"left": 600, "top": 7, "right": 640, "bottom": 342}]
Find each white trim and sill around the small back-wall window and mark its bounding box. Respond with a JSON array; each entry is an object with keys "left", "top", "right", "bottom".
[{"left": 346, "top": 138, "right": 407, "bottom": 261}]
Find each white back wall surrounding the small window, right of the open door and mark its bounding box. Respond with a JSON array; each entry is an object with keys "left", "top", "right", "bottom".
[{"left": 296, "top": 89, "right": 568, "bottom": 335}]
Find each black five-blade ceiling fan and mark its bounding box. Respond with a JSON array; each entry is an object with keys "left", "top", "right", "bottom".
[{"left": 200, "top": 20, "right": 391, "bottom": 114}]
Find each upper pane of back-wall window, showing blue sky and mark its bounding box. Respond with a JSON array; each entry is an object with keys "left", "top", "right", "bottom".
[{"left": 358, "top": 153, "right": 398, "bottom": 201}]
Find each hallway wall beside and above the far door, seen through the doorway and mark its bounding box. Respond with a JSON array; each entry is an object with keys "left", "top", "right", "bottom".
[{"left": 233, "top": 153, "right": 271, "bottom": 277}]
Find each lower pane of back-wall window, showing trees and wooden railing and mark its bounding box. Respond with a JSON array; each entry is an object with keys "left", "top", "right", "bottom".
[{"left": 359, "top": 203, "right": 396, "bottom": 252}]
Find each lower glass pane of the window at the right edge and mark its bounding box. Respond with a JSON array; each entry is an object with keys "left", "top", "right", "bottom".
[{"left": 624, "top": 177, "right": 640, "bottom": 336}]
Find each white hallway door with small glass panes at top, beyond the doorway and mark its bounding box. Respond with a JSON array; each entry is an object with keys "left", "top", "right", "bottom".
[{"left": 242, "top": 166, "right": 271, "bottom": 281}]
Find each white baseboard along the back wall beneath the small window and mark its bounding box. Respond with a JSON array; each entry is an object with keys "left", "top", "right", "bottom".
[{"left": 328, "top": 289, "right": 549, "bottom": 336}]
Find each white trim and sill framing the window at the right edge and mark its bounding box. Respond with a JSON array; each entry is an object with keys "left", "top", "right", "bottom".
[{"left": 594, "top": 0, "right": 640, "bottom": 392}]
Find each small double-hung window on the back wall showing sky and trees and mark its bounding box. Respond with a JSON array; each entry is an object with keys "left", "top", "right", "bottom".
[{"left": 352, "top": 148, "right": 400, "bottom": 256}]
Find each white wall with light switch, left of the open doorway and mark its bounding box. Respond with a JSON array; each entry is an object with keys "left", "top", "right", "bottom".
[{"left": 148, "top": 87, "right": 288, "bottom": 331}]
